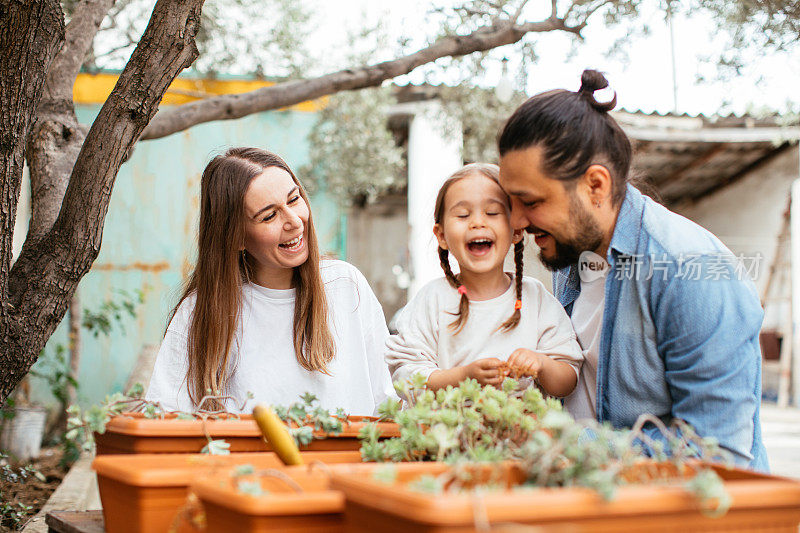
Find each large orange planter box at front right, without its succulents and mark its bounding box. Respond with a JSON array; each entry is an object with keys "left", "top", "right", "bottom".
[{"left": 331, "top": 463, "right": 800, "bottom": 533}]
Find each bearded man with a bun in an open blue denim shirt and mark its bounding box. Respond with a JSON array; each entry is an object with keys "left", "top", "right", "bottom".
[{"left": 498, "top": 70, "right": 768, "bottom": 471}]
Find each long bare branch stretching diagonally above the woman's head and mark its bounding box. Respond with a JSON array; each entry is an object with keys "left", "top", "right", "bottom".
[{"left": 142, "top": 15, "right": 564, "bottom": 139}]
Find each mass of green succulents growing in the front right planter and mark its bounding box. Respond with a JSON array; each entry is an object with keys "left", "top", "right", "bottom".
[{"left": 359, "top": 376, "right": 731, "bottom": 515}]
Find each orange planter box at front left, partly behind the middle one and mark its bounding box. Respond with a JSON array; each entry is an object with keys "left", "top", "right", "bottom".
[{"left": 92, "top": 451, "right": 361, "bottom": 533}]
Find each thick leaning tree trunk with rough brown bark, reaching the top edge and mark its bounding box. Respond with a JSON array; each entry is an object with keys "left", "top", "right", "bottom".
[{"left": 0, "top": 0, "right": 203, "bottom": 398}]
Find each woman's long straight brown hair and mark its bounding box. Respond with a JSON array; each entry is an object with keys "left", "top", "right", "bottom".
[{"left": 170, "top": 148, "right": 335, "bottom": 409}]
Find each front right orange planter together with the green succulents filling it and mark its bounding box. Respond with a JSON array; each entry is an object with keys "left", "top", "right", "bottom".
[{"left": 331, "top": 380, "right": 800, "bottom": 531}]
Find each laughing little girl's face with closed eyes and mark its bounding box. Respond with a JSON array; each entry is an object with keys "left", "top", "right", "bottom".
[{"left": 433, "top": 173, "right": 512, "bottom": 274}]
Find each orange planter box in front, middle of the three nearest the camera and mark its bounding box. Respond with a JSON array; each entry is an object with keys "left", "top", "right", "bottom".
[{"left": 191, "top": 465, "right": 352, "bottom": 533}]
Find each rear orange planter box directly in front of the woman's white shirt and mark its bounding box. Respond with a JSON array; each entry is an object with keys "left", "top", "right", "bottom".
[{"left": 95, "top": 413, "right": 400, "bottom": 455}]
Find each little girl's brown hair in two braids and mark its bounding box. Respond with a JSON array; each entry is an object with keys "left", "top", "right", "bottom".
[{"left": 433, "top": 163, "right": 525, "bottom": 335}]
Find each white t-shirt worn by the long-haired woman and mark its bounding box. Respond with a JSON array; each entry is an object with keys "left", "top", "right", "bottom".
[{"left": 146, "top": 260, "right": 395, "bottom": 415}]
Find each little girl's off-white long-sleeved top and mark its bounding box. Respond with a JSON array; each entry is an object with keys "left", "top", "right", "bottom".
[{"left": 386, "top": 277, "right": 583, "bottom": 381}]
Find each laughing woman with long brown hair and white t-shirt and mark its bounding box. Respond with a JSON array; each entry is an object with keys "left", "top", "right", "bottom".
[{"left": 147, "top": 148, "right": 394, "bottom": 415}]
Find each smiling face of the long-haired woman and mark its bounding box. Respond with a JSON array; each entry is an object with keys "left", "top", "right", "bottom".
[{"left": 244, "top": 167, "right": 309, "bottom": 289}]
